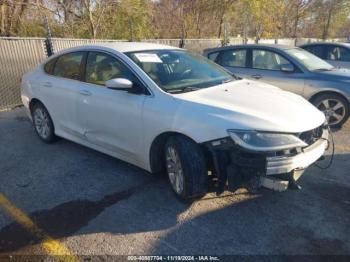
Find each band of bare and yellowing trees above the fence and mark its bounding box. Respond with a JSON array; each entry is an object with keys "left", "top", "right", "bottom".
[{"left": 0, "top": 0, "right": 350, "bottom": 40}]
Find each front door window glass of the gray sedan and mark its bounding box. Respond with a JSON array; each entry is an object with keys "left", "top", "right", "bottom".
[{"left": 253, "top": 50, "right": 291, "bottom": 71}]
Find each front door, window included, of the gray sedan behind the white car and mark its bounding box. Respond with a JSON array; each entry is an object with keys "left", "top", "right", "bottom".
[{"left": 248, "top": 48, "right": 304, "bottom": 95}]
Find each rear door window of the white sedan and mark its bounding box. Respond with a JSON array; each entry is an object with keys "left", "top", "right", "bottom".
[{"left": 53, "top": 52, "right": 84, "bottom": 80}]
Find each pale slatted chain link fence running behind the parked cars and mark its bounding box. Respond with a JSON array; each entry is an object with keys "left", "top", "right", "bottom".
[{"left": 0, "top": 37, "right": 345, "bottom": 111}]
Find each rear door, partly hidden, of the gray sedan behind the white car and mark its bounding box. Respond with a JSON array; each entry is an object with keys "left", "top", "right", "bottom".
[{"left": 209, "top": 48, "right": 248, "bottom": 78}]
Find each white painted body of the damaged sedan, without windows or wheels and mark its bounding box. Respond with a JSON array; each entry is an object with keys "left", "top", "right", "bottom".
[{"left": 22, "top": 43, "right": 325, "bottom": 171}]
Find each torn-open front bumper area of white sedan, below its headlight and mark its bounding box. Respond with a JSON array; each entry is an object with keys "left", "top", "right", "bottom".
[{"left": 205, "top": 127, "right": 329, "bottom": 193}]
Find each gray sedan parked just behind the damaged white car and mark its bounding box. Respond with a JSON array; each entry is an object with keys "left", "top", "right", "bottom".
[{"left": 203, "top": 45, "right": 350, "bottom": 127}]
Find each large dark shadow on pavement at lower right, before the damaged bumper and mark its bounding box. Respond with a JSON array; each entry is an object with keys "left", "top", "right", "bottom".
[{"left": 152, "top": 158, "right": 350, "bottom": 254}]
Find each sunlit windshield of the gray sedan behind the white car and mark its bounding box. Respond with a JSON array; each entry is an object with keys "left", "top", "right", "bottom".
[{"left": 286, "top": 48, "right": 334, "bottom": 71}]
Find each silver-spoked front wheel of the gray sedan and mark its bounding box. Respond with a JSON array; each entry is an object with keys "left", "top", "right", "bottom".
[{"left": 312, "top": 94, "right": 349, "bottom": 128}]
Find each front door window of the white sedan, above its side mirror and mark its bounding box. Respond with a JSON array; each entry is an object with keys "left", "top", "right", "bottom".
[{"left": 85, "top": 52, "right": 138, "bottom": 85}]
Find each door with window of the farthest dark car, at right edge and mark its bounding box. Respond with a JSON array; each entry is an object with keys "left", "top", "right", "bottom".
[{"left": 326, "top": 45, "right": 350, "bottom": 69}]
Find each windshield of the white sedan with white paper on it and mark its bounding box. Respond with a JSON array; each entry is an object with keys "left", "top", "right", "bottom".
[{"left": 127, "top": 50, "right": 235, "bottom": 93}]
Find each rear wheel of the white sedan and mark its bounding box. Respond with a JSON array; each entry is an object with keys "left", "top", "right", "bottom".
[{"left": 32, "top": 103, "right": 56, "bottom": 143}]
